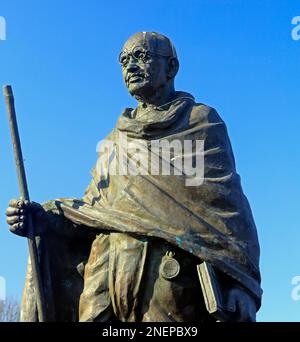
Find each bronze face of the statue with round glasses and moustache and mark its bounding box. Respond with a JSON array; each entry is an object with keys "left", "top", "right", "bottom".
[{"left": 120, "top": 38, "right": 168, "bottom": 100}]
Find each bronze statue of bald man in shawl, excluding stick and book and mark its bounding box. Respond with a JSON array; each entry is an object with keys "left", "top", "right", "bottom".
[{"left": 7, "top": 32, "right": 262, "bottom": 322}]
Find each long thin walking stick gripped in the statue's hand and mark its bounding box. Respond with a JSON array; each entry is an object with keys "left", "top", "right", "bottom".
[{"left": 3, "top": 85, "right": 46, "bottom": 322}]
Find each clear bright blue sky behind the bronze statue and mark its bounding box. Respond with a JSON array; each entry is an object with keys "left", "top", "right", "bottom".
[{"left": 0, "top": 0, "right": 300, "bottom": 321}]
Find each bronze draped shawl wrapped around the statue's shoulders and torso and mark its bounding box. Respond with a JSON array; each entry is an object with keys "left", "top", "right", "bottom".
[{"left": 23, "top": 92, "right": 262, "bottom": 320}]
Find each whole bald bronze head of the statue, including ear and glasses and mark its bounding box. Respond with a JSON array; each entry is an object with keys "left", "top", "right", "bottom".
[{"left": 119, "top": 32, "right": 179, "bottom": 102}]
